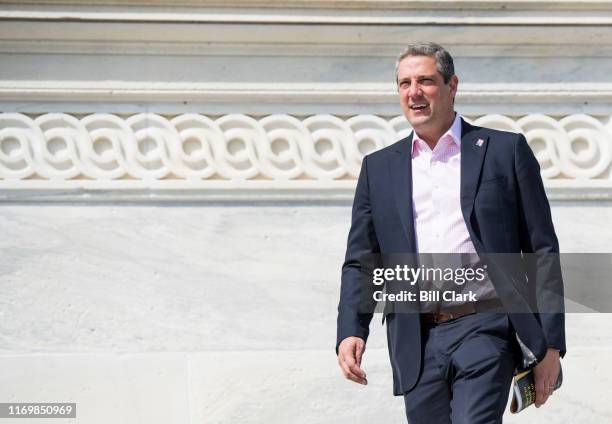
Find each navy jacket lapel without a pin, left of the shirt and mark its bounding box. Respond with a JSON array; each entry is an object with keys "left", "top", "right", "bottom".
[{"left": 389, "top": 133, "right": 416, "bottom": 252}]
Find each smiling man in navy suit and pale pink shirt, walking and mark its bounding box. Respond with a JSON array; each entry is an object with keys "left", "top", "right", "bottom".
[{"left": 336, "top": 43, "right": 565, "bottom": 424}]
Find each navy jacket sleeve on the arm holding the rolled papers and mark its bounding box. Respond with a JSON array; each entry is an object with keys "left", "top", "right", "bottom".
[{"left": 514, "top": 134, "right": 565, "bottom": 355}]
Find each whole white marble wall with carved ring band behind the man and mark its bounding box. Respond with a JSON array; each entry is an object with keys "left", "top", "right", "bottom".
[{"left": 0, "top": 0, "right": 612, "bottom": 424}]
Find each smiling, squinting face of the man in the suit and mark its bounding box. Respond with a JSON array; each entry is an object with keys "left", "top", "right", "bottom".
[{"left": 397, "top": 56, "right": 458, "bottom": 134}]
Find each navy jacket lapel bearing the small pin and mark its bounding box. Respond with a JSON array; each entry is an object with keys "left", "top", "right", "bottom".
[{"left": 460, "top": 119, "right": 489, "bottom": 249}]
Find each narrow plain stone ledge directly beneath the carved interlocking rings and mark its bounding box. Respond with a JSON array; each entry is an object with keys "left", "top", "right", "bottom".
[{"left": 0, "top": 181, "right": 612, "bottom": 205}]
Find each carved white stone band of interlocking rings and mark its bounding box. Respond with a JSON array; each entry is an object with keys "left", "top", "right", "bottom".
[{"left": 0, "top": 113, "right": 612, "bottom": 199}]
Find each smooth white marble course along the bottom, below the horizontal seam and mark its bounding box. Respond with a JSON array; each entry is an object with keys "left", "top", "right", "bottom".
[{"left": 0, "top": 349, "right": 612, "bottom": 424}]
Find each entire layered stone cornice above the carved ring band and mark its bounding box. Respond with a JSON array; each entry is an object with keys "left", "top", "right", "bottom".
[{"left": 0, "top": 0, "right": 612, "bottom": 116}]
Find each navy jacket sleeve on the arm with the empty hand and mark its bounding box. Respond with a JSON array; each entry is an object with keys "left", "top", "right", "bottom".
[{"left": 336, "top": 157, "right": 380, "bottom": 353}]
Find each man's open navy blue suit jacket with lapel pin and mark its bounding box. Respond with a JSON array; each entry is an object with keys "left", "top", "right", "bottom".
[{"left": 336, "top": 121, "right": 565, "bottom": 395}]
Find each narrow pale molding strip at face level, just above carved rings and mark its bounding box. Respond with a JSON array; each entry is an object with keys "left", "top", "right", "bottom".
[{"left": 0, "top": 82, "right": 612, "bottom": 116}]
